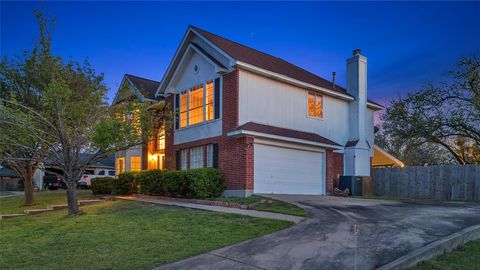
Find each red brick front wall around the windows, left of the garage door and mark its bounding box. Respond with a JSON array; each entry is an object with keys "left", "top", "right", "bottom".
[{"left": 165, "top": 70, "right": 253, "bottom": 192}]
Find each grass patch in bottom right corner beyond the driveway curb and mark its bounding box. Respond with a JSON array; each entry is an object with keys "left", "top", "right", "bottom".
[{"left": 411, "top": 240, "right": 480, "bottom": 270}]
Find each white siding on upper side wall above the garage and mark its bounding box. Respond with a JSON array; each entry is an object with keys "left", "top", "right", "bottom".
[{"left": 239, "top": 70, "right": 349, "bottom": 144}]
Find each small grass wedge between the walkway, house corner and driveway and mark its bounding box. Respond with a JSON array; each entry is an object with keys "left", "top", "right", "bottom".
[{"left": 212, "top": 195, "right": 308, "bottom": 217}]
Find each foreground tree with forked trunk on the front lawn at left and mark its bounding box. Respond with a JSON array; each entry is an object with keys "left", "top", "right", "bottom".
[{"left": 0, "top": 12, "right": 171, "bottom": 215}]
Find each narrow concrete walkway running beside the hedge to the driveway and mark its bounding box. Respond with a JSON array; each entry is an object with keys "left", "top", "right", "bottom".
[{"left": 117, "top": 196, "right": 304, "bottom": 223}]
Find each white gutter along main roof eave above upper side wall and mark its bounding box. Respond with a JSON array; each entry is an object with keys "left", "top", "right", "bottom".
[{"left": 236, "top": 61, "right": 355, "bottom": 100}]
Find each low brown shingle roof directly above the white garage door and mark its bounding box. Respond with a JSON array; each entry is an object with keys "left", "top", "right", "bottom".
[{"left": 233, "top": 122, "right": 340, "bottom": 146}]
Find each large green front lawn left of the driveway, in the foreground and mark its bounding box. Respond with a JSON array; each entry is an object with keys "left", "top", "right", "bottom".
[{"left": 0, "top": 201, "right": 292, "bottom": 270}]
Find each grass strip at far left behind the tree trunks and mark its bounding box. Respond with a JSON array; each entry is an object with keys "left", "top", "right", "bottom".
[{"left": 0, "top": 189, "right": 101, "bottom": 214}]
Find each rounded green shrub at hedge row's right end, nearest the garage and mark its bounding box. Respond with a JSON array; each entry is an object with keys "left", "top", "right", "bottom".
[{"left": 186, "top": 168, "right": 223, "bottom": 199}]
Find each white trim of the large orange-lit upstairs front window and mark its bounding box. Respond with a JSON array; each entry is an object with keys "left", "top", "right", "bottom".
[{"left": 174, "top": 76, "right": 223, "bottom": 130}]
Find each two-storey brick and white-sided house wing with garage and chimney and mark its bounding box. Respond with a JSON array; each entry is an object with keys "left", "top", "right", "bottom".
[{"left": 111, "top": 26, "right": 383, "bottom": 196}]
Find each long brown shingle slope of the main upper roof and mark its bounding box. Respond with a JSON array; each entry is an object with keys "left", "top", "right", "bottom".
[{"left": 191, "top": 26, "right": 350, "bottom": 95}]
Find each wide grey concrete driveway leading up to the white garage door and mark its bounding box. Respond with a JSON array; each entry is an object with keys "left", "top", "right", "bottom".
[{"left": 158, "top": 195, "right": 480, "bottom": 269}]
